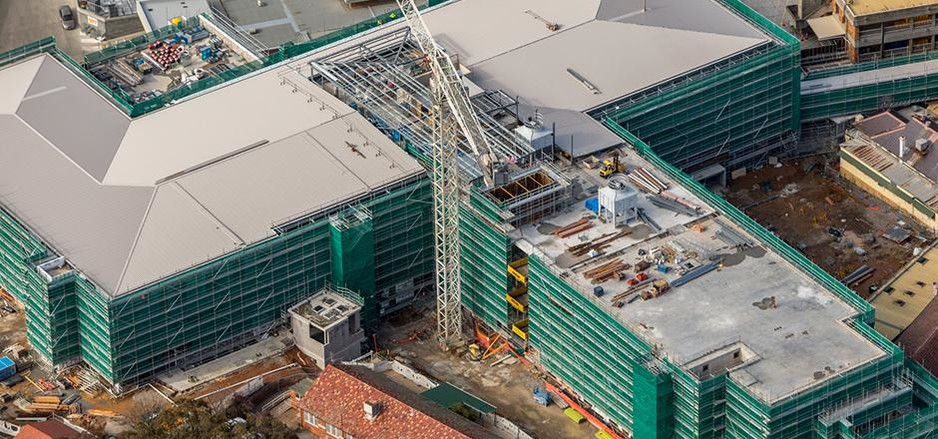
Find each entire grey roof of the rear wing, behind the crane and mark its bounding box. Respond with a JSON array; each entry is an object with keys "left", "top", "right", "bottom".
[{"left": 304, "top": 0, "right": 771, "bottom": 156}]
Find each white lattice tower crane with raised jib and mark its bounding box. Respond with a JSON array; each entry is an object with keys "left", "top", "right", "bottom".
[{"left": 397, "top": 0, "right": 500, "bottom": 349}]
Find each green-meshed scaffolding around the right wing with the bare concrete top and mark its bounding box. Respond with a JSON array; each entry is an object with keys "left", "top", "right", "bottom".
[{"left": 576, "top": 120, "right": 938, "bottom": 439}]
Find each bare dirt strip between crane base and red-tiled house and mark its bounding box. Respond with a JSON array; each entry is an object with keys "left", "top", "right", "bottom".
[{"left": 378, "top": 308, "right": 596, "bottom": 439}]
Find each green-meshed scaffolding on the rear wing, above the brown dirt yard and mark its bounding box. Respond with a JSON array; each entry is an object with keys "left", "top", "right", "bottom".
[{"left": 590, "top": 0, "right": 801, "bottom": 170}]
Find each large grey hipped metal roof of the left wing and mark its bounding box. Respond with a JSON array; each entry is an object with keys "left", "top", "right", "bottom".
[{"left": 0, "top": 55, "right": 423, "bottom": 296}]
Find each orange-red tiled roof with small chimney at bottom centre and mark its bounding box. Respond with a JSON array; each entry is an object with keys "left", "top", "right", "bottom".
[{"left": 297, "top": 365, "right": 495, "bottom": 439}]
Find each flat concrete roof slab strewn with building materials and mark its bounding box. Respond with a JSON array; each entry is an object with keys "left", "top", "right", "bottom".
[{"left": 512, "top": 154, "right": 885, "bottom": 403}]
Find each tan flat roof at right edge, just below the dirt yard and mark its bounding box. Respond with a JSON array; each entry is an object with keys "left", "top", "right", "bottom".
[{"left": 870, "top": 247, "right": 938, "bottom": 341}]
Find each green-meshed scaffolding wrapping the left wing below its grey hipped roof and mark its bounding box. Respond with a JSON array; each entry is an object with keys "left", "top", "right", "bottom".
[{"left": 0, "top": 176, "right": 433, "bottom": 389}]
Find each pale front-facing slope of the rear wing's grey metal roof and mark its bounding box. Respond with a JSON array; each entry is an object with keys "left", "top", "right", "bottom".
[{"left": 471, "top": 21, "right": 765, "bottom": 111}]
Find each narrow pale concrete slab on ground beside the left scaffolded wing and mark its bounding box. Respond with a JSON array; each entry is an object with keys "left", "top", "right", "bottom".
[{"left": 158, "top": 336, "right": 290, "bottom": 392}]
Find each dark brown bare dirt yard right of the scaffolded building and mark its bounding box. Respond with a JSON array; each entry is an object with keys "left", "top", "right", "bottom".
[{"left": 725, "top": 159, "right": 932, "bottom": 298}]
